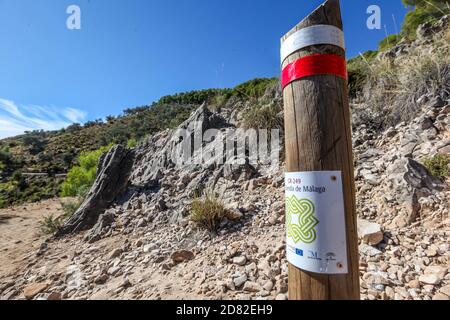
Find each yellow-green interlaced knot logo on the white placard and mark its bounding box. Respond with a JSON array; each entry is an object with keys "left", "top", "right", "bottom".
[{"left": 286, "top": 195, "right": 320, "bottom": 244}]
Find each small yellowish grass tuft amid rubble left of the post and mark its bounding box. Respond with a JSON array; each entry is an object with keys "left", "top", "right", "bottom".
[{"left": 190, "top": 192, "right": 226, "bottom": 232}]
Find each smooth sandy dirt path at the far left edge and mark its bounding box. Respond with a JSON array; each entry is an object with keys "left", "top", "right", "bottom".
[{"left": 0, "top": 199, "right": 61, "bottom": 279}]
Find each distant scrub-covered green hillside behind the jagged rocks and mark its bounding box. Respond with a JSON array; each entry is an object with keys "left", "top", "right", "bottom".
[{"left": 0, "top": 79, "right": 278, "bottom": 208}]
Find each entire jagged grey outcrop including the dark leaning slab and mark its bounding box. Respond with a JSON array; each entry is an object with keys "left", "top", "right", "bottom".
[{"left": 57, "top": 105, "right": 258, "bottom": 242}]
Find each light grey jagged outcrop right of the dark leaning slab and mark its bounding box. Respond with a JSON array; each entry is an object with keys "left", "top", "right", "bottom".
[{"left": 119, "top": 105, "right": 257, "bottom": 228}]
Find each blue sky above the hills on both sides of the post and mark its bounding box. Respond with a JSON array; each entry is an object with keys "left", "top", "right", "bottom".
[{"left": 0, "top": 0, "right": 407, "bottom": 138}]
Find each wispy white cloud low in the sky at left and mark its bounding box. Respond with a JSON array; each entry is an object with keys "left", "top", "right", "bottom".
[{"left": 0, "top": 98, "right": 87, "bottom": 139}]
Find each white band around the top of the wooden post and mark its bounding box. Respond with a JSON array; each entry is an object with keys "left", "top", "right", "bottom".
[{"left": 281, "top": 25, "right": 345, "bottom": 63}]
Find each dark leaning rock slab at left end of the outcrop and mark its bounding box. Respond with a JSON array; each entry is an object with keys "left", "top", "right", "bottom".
[{"left": 56, "top": 145, "right": 134, "bottom": 237}]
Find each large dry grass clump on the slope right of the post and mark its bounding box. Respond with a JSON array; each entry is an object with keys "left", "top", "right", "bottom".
[{"left": 364, "top": 30, "right": 450, "bottom": 127}]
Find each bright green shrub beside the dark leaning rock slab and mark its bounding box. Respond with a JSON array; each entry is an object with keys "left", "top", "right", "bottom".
[{"left": 61, "top": 146, "right": 111, "bottom": 197}]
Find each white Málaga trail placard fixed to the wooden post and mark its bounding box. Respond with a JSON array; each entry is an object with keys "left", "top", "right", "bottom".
[{"left": 285, "top": 171, "right": 348, "bottom": 274}]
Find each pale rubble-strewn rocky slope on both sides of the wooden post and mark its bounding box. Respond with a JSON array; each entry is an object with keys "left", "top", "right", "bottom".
[{"left": 0, "top": 17, "right": 450, "bottom": 300}]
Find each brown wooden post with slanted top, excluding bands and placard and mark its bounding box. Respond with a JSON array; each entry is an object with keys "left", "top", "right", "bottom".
[{"left": 281, "top": 0, "right": 360, "bottom": 300}]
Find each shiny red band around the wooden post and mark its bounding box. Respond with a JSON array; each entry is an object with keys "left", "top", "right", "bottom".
[{"left": 281, "top": 54, "right": 347, "bottom": 89}]
